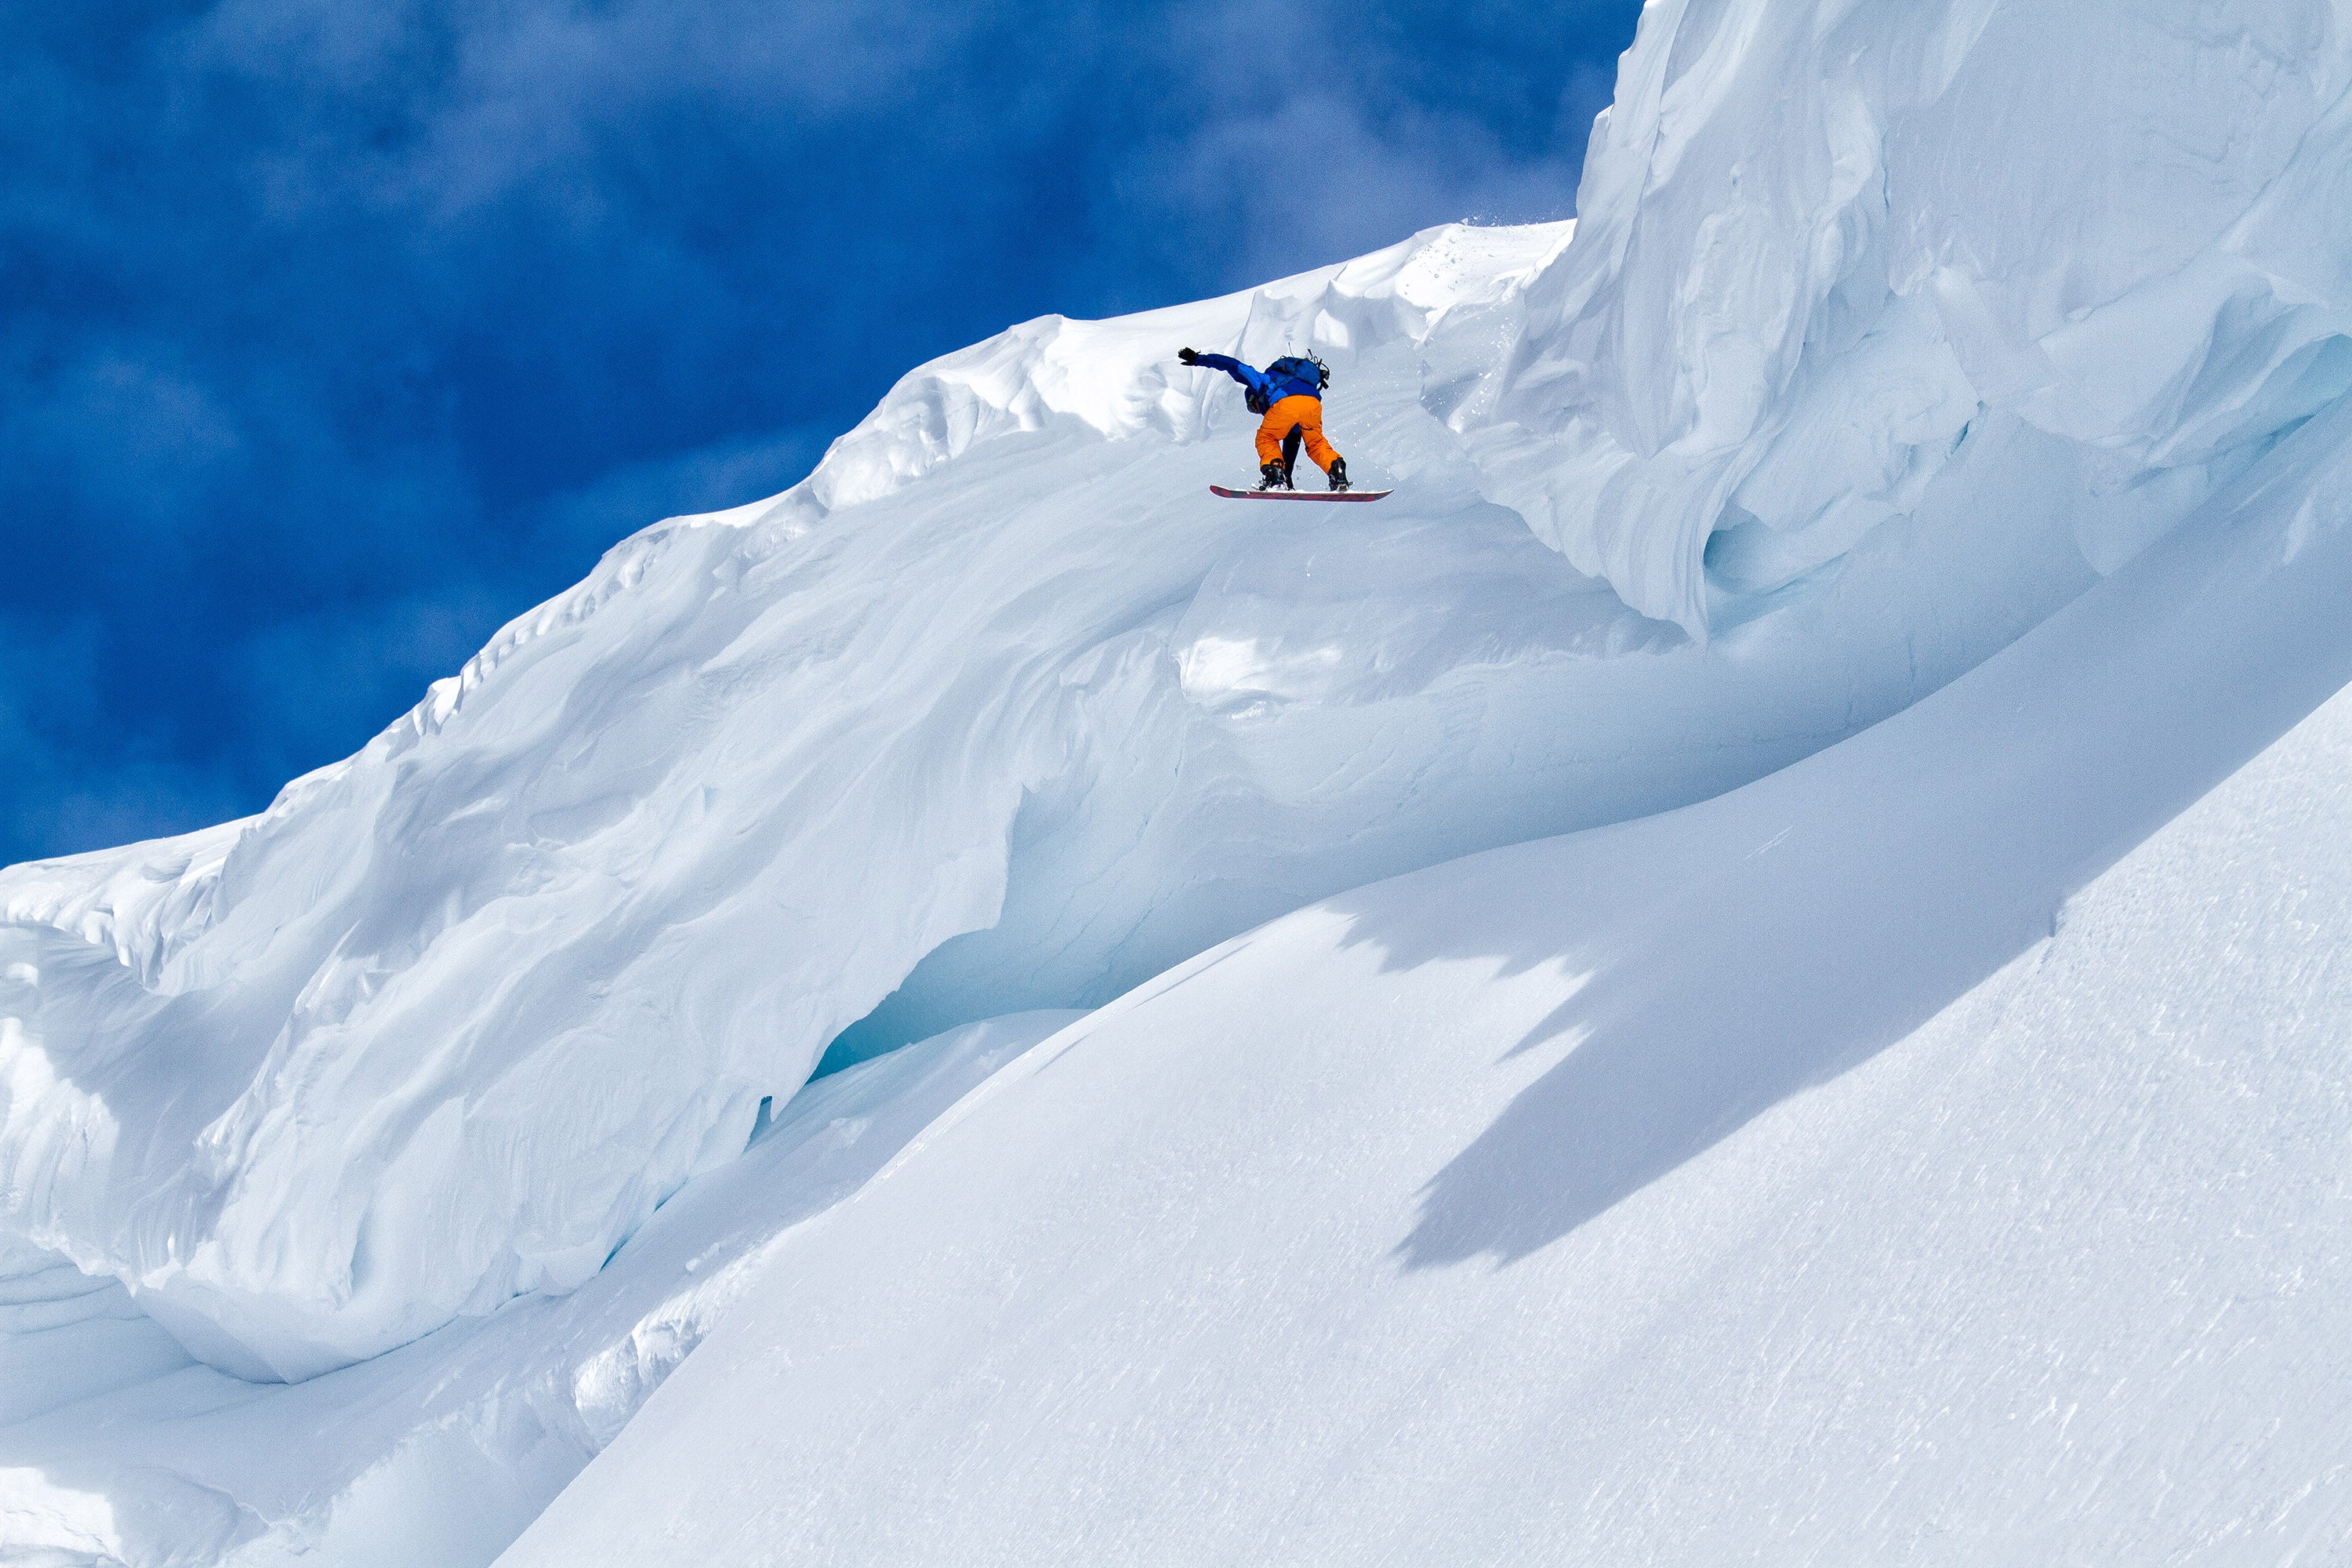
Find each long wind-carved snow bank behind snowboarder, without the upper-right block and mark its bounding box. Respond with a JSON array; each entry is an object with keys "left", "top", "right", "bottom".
[{"left": 0, "top": 205, "right": 2126, "bottom": 1377}]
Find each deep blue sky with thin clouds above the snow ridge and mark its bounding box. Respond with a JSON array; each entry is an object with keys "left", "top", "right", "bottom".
[{"left": 0, "top": 0, "right": 1639, "bottom": 862}]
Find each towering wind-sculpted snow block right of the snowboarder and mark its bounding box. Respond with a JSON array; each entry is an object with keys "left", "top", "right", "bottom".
[{"left": 1454, "top": 0, "right": 2352, "bottom": 633}]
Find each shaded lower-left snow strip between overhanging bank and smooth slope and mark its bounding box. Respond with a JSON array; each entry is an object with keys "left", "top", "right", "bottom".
[{"left": 0, "top": 1013, "right": 1080, "bottom": 1568}]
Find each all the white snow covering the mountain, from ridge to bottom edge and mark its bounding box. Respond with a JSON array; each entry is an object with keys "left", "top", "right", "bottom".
[{"left": 0, "top": 0, "right": 2352, "bottom": 1566}]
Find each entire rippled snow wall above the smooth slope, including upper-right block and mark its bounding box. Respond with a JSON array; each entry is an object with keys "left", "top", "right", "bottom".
[{"left": 0, "top": 0, "right": 2347, "bottom": 1377}]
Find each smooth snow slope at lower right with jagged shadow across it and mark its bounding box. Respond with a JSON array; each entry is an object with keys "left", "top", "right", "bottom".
[{"left": 501, "top": 380, "right": 2352, "bottom": 1568}]
